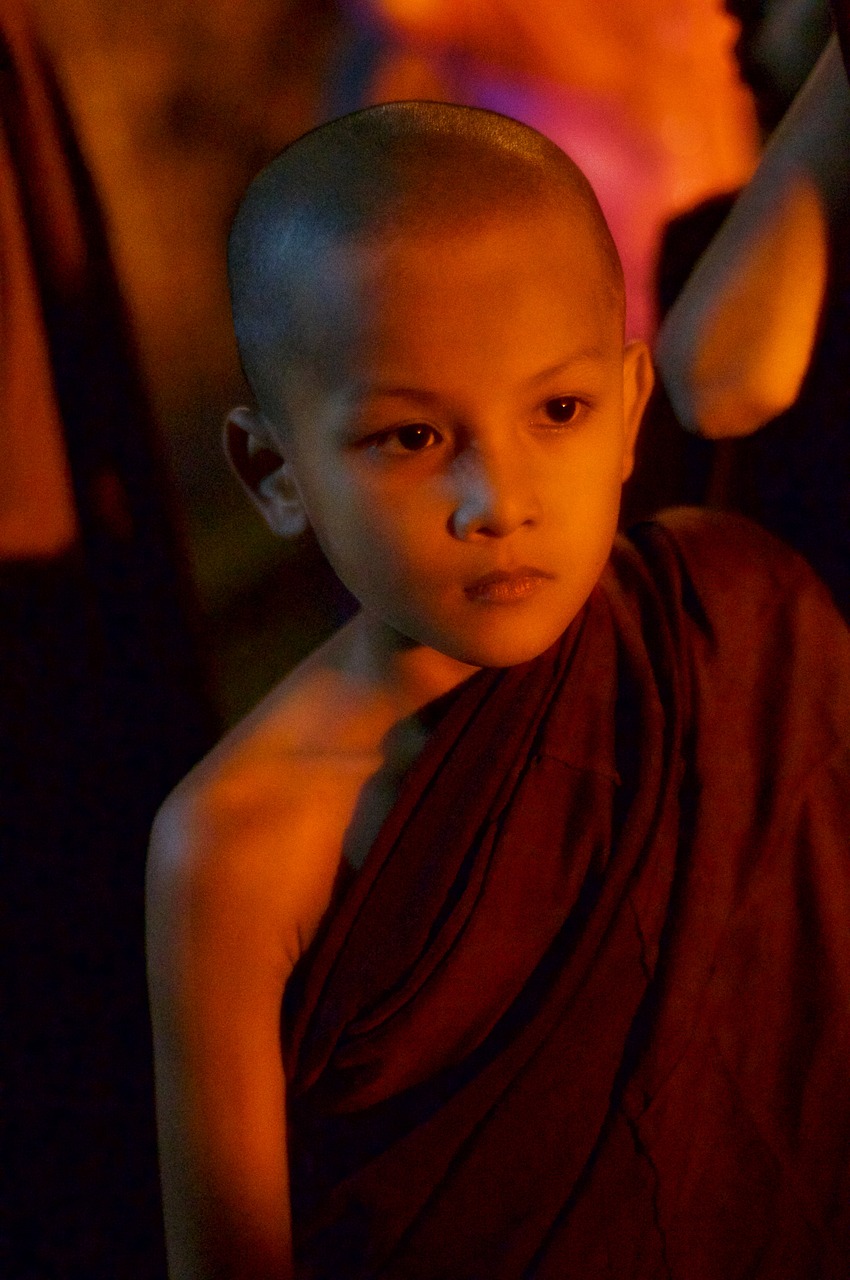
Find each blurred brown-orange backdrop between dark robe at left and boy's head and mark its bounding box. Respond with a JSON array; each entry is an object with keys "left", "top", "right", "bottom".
[{"left": 26, "top": 0, "right": 346, "bottom": 723}]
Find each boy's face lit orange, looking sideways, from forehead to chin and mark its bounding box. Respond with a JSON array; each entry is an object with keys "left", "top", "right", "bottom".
[{"left": 250, "top": 204, "right": 652, "bottom": 667}]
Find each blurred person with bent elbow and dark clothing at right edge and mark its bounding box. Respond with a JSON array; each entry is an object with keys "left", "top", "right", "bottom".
[{"left": 650, "top": 5, "right": 850, "bottom": 617}]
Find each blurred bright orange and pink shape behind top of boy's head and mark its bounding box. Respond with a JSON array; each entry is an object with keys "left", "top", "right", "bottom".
[{"left": 329, "top": 0, "right": 758, "bottom": 337}]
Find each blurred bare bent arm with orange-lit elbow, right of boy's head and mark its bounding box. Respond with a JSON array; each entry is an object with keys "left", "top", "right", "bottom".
[{"left": 655, "top": 38, "right": 850, "bottom": 438}]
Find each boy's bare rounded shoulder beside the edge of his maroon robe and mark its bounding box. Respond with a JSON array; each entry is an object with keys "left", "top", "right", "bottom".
[{"left": 147, "top": 619, "right": 381, "bottom": 973}]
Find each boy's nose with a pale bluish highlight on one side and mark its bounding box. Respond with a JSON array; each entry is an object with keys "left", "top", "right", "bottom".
[{"left": 451, "top": 447, "right": 538, "bottom": 541}]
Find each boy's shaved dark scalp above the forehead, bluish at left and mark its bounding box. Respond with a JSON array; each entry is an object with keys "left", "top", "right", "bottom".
[{"left": 228, "top": 101, "right": 625, "bottom": 421}]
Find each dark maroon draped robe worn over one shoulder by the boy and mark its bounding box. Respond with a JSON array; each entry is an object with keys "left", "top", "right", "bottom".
[{"left": 283, "top": 511, "right": 850, "bottom": 1280}]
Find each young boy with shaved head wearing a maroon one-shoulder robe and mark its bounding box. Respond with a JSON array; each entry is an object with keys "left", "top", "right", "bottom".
[{"left": 148, "top": 102, "right": 850, "bottom": 1280}]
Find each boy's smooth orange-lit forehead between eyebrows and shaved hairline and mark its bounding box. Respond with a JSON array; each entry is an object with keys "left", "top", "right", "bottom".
[{"left": 295, "top": 202, "right": 622, "bottom": 384}]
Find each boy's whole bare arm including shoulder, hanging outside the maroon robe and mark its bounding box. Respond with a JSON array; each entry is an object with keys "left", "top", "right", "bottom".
[{"left": 147, "top": 650, "right": 409, "bottom": 1280}]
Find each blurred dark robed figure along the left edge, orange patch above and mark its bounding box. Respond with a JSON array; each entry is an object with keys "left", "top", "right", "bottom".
[{"left": 0, "top": 0, "right": 214, "bottom": 1280}]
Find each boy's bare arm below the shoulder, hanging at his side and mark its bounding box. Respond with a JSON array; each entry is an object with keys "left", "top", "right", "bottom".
[{"left": 147, "top": 803, "right": 293, "bottom": 1280}]
